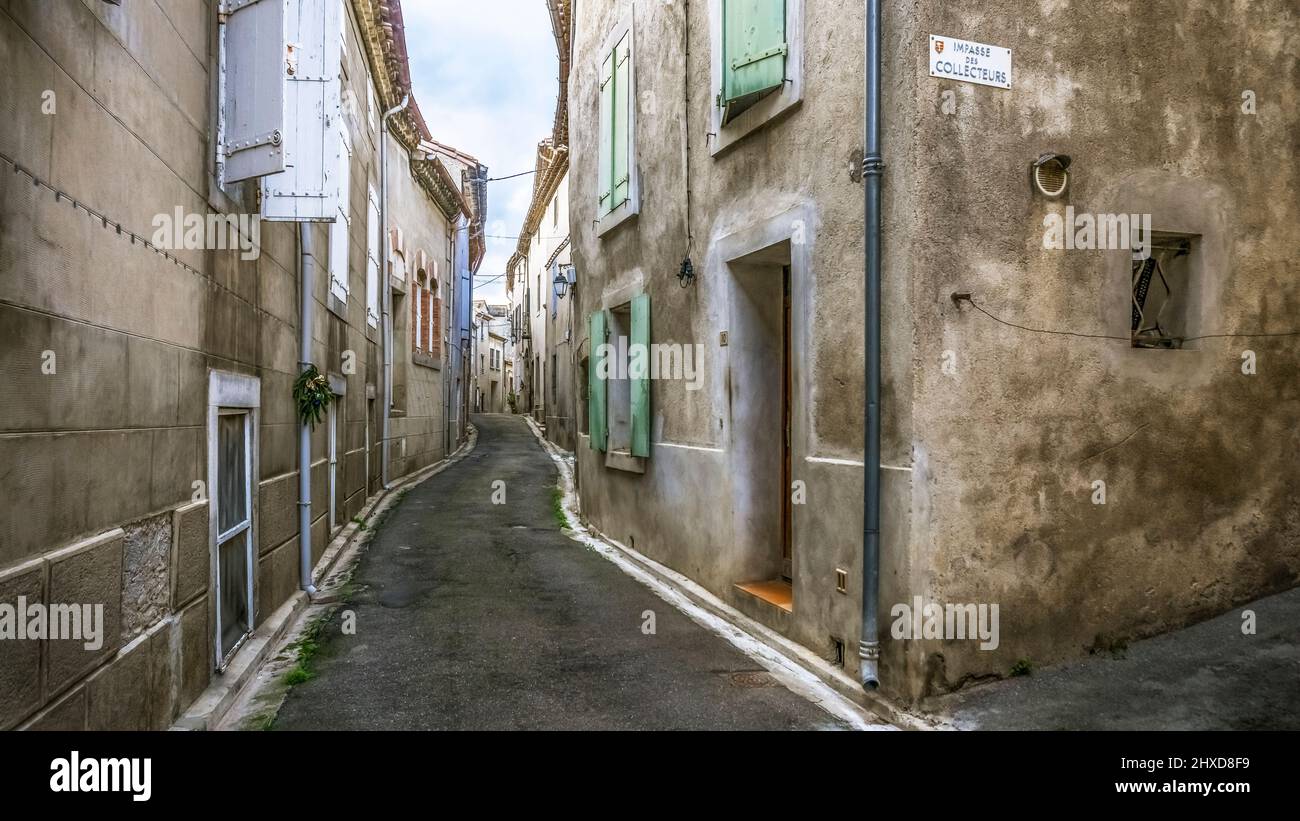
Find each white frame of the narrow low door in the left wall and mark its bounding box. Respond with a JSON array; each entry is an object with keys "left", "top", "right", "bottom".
[{"left": 207, "top": 370, "right": 261, "bottom": 672}]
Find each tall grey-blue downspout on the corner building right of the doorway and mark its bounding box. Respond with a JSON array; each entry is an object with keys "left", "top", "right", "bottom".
[{"left": 858, "top": 0, "right": 884, "bottom": 690}]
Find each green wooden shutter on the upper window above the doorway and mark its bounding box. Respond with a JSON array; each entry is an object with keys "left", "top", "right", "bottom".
[{"left": 720, "top": 0, "right": 789, "bottom": 122}]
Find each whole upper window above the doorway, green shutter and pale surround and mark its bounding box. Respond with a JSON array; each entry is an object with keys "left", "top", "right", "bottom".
[{"left": 710, "top": 0, "right": 803, "bottom": 155}]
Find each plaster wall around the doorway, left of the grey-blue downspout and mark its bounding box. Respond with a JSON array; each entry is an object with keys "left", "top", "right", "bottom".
[{"left": 569, "top": 1, "right": 914, "bottom": 683}]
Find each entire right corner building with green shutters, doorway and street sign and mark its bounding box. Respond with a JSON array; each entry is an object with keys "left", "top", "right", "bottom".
[{"left": 572, "top": 0, "right": 1300, "bottom": 700}]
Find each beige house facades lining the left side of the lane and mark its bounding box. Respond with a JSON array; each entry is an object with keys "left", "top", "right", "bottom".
[{"left": 0, "top": 0, "right": 486, "bottom": 729}]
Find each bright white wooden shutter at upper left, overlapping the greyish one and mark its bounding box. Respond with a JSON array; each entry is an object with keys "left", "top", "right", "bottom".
[{"left": 259, "top": 0, "right": 345, "bottom": 222}]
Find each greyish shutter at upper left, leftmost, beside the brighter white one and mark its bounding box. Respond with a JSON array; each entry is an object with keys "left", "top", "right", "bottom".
[{"left": 220, "top": 0, "right": 286, "bottom": 182}]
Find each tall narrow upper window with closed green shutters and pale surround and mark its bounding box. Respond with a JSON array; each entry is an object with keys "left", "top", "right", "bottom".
[{"left": 595, "top": 17, "right": 640, "bottom": 235}]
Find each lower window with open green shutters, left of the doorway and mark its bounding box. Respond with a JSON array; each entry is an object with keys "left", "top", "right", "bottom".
[{"left": 586, "top": 294, "right": 651, "bottom": 473}]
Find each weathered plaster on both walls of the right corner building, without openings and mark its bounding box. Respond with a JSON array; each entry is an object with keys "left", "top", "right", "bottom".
[{"left": 569, "top": 0, "right": 1300, "bottom": 699}]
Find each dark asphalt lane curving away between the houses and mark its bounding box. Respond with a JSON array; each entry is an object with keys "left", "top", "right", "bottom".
[{"left": 274, "top": 414, "right": 844, "bottom": 730}]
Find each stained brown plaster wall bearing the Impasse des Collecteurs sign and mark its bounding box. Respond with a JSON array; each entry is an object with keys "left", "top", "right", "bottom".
[{"left": 909, "top": 0, "right": 1300, "bottom": 691}]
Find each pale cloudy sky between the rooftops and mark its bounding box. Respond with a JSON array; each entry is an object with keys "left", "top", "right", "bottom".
[{"left": 402, "top": 0, "right": 559, "bottom": 303}]
